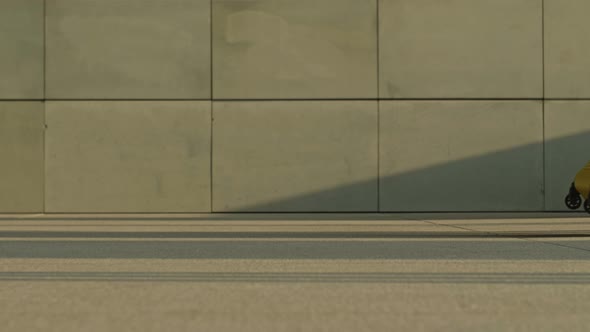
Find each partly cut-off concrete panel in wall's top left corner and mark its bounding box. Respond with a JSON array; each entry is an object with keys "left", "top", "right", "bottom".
[{"left": 0, "top": 0, "right": 44, "bottom": 99}]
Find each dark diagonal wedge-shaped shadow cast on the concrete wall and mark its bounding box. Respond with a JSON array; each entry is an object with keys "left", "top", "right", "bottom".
[{"left": 221, "top": 131, "right": 590, "bottom": 212}]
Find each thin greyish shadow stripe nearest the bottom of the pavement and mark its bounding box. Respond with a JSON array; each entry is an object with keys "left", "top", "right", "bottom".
[{"left": 0, "top": 272, "right": 590, "bottom": 284}]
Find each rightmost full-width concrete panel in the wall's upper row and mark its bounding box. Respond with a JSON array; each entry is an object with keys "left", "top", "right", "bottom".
[{"left": 379, "top": 0, "right": 544, "bottom": 98}]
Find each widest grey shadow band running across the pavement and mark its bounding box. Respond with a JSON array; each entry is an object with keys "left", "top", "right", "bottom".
[{"left": 0, "top": 239, "right": 590, "bottom": 261}]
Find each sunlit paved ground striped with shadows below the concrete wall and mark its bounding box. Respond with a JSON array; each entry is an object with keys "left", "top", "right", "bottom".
[{"left": 0, "top": 214, "right": 590, "bottom": 332}]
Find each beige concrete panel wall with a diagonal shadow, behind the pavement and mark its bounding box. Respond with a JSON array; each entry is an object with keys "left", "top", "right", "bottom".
[{"left": 0, "top": 0, "right": 590, "bottom": 213}]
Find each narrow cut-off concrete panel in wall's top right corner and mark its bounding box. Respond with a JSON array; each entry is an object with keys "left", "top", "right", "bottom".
[{"left": 545, "top": 0, "right": 590, "bottom": 98}]
